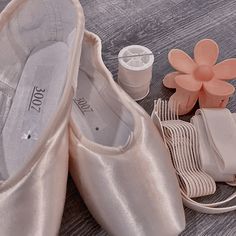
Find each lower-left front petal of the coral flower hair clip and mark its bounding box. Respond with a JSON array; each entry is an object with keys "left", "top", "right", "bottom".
[{"left": 175, "top": 75, "right": 202, "bottom": 92}]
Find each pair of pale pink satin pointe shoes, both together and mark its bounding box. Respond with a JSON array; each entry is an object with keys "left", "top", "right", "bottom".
[{"left": 0, "top": 0, "right": 185, "bottom": 236}]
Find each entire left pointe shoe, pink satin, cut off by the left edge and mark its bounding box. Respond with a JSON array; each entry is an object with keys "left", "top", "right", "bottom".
[{"left": 0, "top": 0, "right": 84, "bottom": 236}]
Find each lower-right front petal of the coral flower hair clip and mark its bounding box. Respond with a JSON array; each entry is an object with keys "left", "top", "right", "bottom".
[{"left": 203, "top": 79, "right": 235, "bottom": 97}]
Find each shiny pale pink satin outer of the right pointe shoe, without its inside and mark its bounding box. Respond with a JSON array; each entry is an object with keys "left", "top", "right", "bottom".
[{"left": 70, "top": 32, "right": 185, "bottom": 236}]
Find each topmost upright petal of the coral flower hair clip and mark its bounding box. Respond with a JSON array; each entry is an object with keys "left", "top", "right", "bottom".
[{"left": 194, "top": 39, "right": 219, "bottom": 66}]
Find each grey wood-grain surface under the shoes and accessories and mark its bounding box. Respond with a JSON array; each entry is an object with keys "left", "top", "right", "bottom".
[{"left": 60, "top": 0, "right": 236, "bottom": 236}]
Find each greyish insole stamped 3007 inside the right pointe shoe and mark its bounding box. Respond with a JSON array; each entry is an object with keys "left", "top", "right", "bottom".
[{"left": 73, "top": 70, "right": 131, "bottom": 147}]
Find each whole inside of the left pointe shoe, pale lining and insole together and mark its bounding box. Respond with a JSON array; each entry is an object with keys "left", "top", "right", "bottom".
[{"left": 0, "top": 0, "right": 76, "bottom": 181}]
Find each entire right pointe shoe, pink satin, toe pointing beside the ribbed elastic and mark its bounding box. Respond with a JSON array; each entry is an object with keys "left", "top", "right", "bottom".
[{"left": 70, "top": 32, "right": 185, "bottom": 236}]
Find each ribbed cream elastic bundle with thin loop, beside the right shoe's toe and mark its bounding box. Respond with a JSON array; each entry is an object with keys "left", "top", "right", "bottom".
[{"left": 152, "top": 99, "right": 236, "bottom": 214}]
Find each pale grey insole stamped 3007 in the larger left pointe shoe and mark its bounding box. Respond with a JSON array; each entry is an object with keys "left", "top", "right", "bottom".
[{"left": 0, "top": 42, "right": 69, "bottom": 178}]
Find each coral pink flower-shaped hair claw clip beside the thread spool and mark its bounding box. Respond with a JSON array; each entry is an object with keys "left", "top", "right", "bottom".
[{"left": 163, "top": 39, "right": 236, "bottom": 115}]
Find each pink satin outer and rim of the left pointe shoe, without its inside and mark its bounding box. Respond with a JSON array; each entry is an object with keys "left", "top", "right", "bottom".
[{"left": 0, "top": 0, "right": 84, "bottom": 236}]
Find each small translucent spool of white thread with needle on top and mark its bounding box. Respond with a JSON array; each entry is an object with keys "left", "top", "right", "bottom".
[{"left": 118, "top": 45, "right": 154, "bottom": 101}]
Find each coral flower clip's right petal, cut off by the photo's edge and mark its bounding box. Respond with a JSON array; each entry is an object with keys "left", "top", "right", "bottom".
[{"left": 213, "top": 58, "right": 236, "bottom": 80}]
